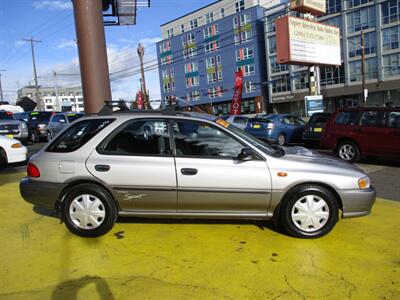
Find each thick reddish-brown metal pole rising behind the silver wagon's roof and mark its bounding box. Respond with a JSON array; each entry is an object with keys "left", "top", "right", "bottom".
[{"left": 72, "top": 0, "right": 112, "bottom": 114}]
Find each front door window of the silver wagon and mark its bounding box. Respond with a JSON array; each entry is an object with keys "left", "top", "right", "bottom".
[{"left": 174, "top": 121, "right": 245, "bottom": 158}]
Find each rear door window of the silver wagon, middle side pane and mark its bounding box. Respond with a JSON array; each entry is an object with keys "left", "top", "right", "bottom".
[{"left": 97, "top": 119, "right": 171, "bottom": 156}]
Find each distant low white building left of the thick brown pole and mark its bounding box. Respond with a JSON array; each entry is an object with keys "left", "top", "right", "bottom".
[{"left": 17, "top": 86, "right": 84, "bottom": 112}]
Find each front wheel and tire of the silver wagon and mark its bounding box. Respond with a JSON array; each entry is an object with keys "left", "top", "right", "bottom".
[{"left": 279, "top": 185, "right": 339, "bottom": 238}]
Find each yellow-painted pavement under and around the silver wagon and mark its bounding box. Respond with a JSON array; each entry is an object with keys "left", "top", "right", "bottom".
[{"left": 0, "top": 145, "right": 400, "bottom": 299}]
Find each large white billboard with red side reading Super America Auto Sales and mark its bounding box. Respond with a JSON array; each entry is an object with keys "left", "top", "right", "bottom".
[{"left": 276, "top": 16, "right": 342, "bottom": 66}]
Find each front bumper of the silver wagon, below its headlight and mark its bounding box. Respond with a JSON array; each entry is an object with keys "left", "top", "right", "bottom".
[{"left": 337, "top": 187, "right": 376, "bottom": 218}]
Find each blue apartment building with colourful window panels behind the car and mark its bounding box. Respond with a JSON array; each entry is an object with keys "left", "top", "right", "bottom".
[{"left": 157, "top": 0, "right": 268, "bottom": 115}]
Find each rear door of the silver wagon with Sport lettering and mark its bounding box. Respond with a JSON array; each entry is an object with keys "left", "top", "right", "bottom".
[{"left": 87, "top": 119, "right": 177, "bottom": 212}]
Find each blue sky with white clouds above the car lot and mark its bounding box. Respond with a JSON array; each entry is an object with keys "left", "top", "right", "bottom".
[{"left": 0, "top": 0, "right": 215, "bottom": 103}]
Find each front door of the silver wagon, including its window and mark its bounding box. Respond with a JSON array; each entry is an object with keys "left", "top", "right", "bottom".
[{"left": 173, "top": 120, "right": 271, "bottom": 216}]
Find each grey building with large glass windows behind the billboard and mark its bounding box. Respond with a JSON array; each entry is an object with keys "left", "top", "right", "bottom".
[{"left": 265, "top": 0, "right": 400, "bottom": 116}]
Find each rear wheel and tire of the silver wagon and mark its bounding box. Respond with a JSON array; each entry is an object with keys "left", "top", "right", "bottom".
[{"left": 62, "top": 184, "right": 118, "bottom": 237}]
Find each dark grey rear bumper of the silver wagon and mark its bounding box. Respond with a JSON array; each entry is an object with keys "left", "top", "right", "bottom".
[{"left": 19, "top": 177, "right": 65, "bottom": 209}]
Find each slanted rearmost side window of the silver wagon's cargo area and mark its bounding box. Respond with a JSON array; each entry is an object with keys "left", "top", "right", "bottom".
[{"left": 46, "top": 119, "right": 114, "bottom": 153}]
